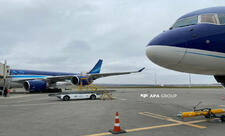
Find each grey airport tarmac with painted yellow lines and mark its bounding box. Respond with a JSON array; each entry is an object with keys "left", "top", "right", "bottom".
[{"left": 0, "top": 88, "right": 225, "bottom": 136}]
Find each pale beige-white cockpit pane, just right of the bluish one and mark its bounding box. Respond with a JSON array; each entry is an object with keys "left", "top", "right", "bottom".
[{"left": 199, "top": 14, "right": 219, "bottom": 24}]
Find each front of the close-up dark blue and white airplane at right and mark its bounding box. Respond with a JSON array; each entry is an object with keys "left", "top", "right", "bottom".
[{"left": 146, "top": 7, "right": 225, "bottom": 86}]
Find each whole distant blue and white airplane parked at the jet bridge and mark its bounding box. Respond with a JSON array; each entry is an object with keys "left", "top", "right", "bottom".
[{"left": 0, "top": 59, "right": 144, "bottom": 92}]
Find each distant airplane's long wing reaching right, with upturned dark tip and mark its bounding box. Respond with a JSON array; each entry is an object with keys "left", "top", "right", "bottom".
[{"left": 90, "top": 67, "right": 145, "bottom": 80}]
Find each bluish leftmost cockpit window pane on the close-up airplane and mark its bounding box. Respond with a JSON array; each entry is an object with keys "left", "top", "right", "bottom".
[{"left": 173, "top": 16, "right": 198, "bottom": 28}]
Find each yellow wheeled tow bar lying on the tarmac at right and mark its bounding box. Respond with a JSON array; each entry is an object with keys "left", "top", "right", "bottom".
[{"left": 177, "top": 103, "right": 225, "bottom": 122}]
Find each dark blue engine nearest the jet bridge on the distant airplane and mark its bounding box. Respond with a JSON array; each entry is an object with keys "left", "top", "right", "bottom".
[{"left": 23, "top": 80, "right": 47, "bottom": 91}]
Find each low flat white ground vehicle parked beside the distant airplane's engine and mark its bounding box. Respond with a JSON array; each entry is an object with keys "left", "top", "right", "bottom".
[{"left": 49, "top": 91, "right": 104, "bottom": 101}]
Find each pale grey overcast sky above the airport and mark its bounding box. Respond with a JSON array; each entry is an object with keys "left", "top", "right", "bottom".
[{"left": 0, "top": 0, "right": 225, "bottom": 84}]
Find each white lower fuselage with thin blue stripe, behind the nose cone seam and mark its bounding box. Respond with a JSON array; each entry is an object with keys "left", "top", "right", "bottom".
[{"left": 177, "top": 49, "right": 225, "bottom": 75}]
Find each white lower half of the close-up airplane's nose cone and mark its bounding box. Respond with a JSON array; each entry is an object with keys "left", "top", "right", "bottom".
[{"left": 146, "top": 45, "right": 185, "bottom": 69}]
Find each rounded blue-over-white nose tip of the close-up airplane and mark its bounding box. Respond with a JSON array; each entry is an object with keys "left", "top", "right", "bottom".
[{"left": 146, "top": 30, "right": 186, "bottom": 69}]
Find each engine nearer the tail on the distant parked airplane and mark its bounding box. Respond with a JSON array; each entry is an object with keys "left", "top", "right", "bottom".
[{"left": 71, "top": 76, "right": 93, "bottom": 86}]
